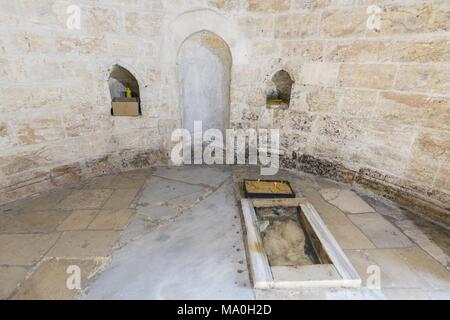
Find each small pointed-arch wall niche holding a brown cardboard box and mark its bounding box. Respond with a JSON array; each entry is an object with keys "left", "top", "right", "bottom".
[{"left": 108, "top": 65, "right": 141, "bottom": 116}]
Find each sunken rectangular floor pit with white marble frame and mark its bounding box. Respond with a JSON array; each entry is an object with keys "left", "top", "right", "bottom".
[{"left": 241, "top": 198, "right": 361, "bottom": 289}]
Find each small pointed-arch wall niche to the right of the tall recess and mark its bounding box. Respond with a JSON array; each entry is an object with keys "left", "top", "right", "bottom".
[{"left": 266, "top": 70, "right": 294, "bottom": 109}]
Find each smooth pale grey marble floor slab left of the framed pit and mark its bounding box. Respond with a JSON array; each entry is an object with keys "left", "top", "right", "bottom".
[{"left": 86, "top": 179, "right": 252, "bottom": 299}]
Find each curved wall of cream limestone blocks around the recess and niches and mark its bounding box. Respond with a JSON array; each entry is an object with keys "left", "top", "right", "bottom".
[{"left": 0, "top": 0, "right": 450, "bottom": 224}]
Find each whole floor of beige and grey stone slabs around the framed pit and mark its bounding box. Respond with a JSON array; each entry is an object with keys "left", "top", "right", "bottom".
[{"left": 0, "top": 166, "right": 450, "bottom": 299}]
